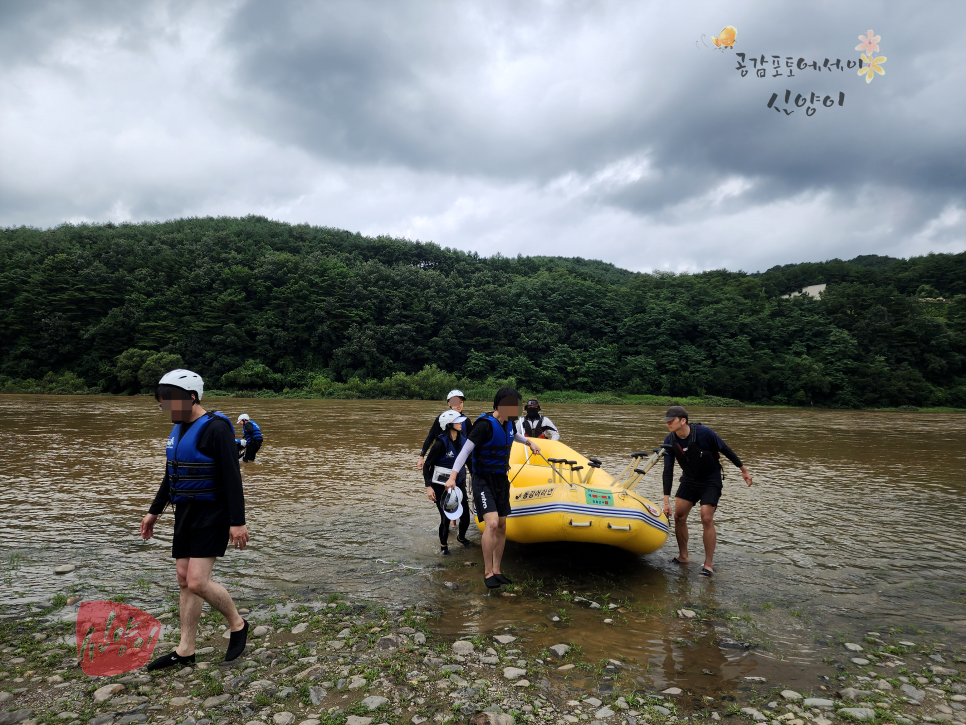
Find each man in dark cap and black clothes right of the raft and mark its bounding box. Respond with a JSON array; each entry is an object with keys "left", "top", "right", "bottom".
[{"left": 661, "top": 405, "right": 752, "bottom": 577}]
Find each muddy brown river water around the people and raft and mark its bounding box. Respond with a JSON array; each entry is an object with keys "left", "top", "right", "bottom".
[{"left": 0, "top": 396, "right": 966, "bottom": 686}]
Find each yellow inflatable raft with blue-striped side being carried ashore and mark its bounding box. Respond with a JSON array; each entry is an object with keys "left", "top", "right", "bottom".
[{"left": 474, "top": 440, "right": 670, "bottom": 554}]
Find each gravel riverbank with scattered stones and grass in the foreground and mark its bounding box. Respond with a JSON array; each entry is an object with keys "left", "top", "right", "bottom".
[{"left": 0, "top": 597, "right": 966, "bottom": 725}]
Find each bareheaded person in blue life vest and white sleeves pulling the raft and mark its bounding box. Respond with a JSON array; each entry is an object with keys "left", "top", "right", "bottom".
[{"left": 446, "top": 388, "right": 540, "bottom": 589}]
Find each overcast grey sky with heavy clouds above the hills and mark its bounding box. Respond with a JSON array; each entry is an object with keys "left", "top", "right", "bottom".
[{"left": 0, "top": 0, "right": 966, "bottom": 271}]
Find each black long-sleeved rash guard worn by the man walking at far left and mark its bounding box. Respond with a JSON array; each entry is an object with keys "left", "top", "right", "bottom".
[{"left": 148, "top": 416, "right": 245, "bottom": 526}]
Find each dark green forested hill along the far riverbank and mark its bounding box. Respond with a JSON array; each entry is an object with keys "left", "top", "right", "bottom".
[{"left": 0, "top": 217, "right": 966, "bottom": 407}]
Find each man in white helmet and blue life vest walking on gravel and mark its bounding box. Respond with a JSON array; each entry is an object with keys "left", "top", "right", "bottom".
[{"left": 141, "top": 370, "right": 248, "bottom": 670}]
